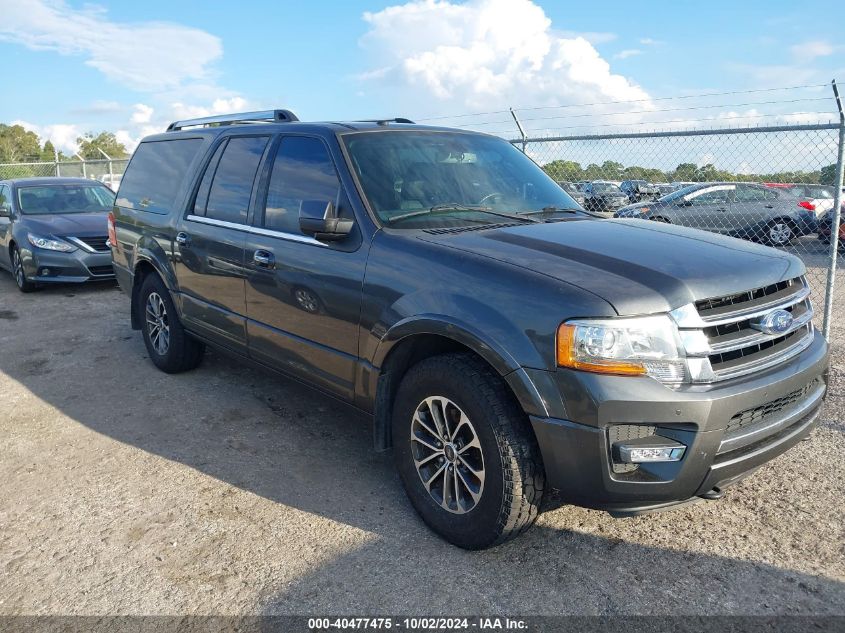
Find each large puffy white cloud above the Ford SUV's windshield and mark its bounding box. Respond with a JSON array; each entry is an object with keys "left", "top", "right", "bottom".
[{"left": 358, "top": 0, "right": 648, "bottom": 114}]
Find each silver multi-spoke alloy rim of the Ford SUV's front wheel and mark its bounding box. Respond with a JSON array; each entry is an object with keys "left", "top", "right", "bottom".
[{"left": 411, "top": 396, "right": 484, "bottom": 514}]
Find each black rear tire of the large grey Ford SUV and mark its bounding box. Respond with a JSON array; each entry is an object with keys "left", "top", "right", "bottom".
[{"left": 137, "top": 274, "right": 205, "bottom": 374}]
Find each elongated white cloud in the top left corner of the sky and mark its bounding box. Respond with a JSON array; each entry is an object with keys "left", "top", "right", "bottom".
[{"left": 0, "top": 0, "right": 223, "bottom": 92}]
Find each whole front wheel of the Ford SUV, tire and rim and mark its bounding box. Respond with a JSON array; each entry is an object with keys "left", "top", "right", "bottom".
[{"left": 392, "top": 354, "right": 545, "bottom": 549}]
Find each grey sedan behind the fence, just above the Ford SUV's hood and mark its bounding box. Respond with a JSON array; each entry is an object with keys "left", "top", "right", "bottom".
[{"left": 616, "top": 182, "right": 817, "bottom": 246}]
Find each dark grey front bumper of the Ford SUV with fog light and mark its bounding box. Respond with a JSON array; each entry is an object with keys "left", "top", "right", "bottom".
[{"left": 529, "top": 333, "right": 828, "bottom": 514}]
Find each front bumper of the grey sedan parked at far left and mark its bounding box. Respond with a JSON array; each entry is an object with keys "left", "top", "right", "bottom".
[{"left": 21, "top": 248, "right": 114, "bottom": 283}]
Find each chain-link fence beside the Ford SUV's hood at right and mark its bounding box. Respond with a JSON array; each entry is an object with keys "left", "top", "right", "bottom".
[{"left": 511, "top": 124, "right": 845, "bottom": 346}]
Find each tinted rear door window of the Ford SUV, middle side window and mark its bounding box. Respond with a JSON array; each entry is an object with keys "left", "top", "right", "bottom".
[{"left": 194, "top": 136, "right": 269, "bottom": 224}]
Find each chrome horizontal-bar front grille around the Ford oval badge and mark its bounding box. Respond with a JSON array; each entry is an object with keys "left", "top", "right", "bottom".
[{"left": 676, "top": 277, "right": 814, "bottom": 382}]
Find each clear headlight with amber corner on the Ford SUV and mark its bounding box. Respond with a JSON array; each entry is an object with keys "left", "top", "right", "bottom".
[{"left": 557, "top": 315, "right": 686, "bottom": 383}]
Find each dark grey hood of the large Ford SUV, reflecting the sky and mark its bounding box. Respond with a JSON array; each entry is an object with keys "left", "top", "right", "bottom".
[{"left": 420, "top": 219, "right": 804, "bottom": 316}]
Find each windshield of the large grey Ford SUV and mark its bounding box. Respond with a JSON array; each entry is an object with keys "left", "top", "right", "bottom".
[{"left": 342, "top": 131, "right": 580, "bottom": 228}]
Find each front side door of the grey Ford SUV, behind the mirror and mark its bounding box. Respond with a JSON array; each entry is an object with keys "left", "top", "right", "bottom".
[{"left": 246, "top": 135, "right": 367, "bottom": 399}]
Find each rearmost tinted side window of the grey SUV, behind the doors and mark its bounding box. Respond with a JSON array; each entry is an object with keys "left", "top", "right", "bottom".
[{"left": 117, "top": 138, "right": 203, "bottom": 213}]
